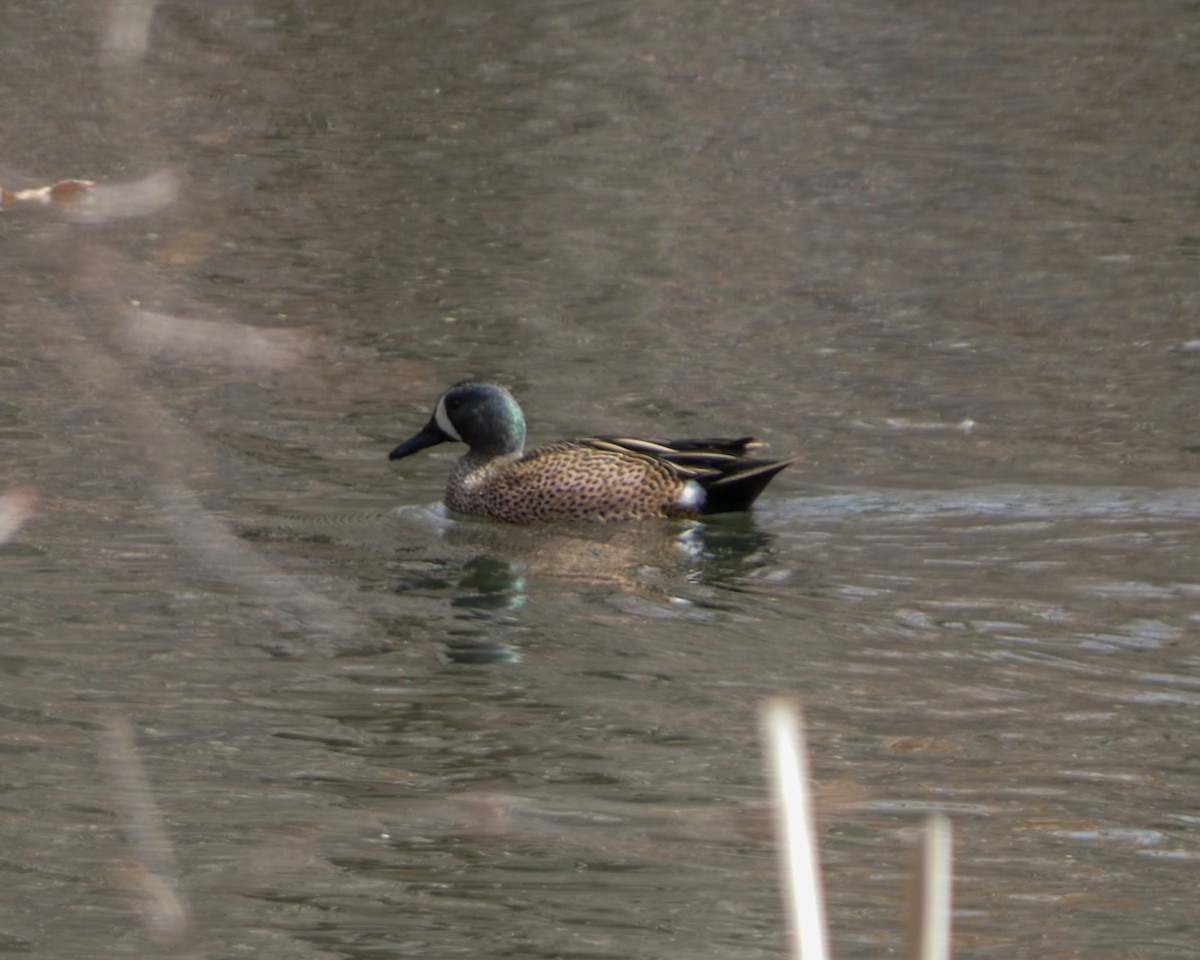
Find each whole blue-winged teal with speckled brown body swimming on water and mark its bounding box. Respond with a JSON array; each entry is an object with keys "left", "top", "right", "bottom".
[{"left": 389, "top": 380, "right": 792, "bottom": 523}]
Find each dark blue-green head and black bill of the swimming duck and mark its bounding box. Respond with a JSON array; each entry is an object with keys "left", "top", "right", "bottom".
[{"left": 388, "top": 380, "right": 524, "bottom": 460}]
